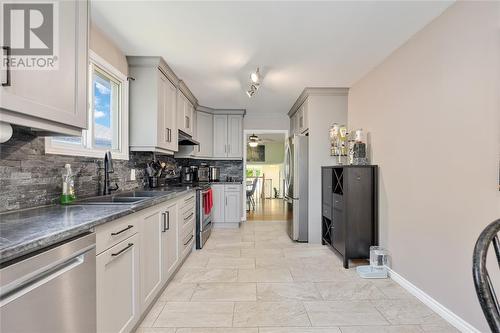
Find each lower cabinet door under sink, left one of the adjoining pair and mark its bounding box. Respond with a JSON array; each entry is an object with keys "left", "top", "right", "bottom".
[{"left": 140, "top": 211, "right": 163, "bottom": 309}]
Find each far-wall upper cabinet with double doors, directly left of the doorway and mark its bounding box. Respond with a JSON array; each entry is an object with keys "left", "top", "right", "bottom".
[{"left": 213, "top": 115, "right": 243, "bottom": 159}]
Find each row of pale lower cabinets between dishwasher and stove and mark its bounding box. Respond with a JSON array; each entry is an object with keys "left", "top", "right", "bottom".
[{"left": 96, "top": 193, "right": 196, "bottom": 333}]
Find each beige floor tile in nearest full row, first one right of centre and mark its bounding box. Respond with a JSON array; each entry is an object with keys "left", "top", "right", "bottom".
[{"left": 304, "top": 301, "right": 389, "bottom": 327}]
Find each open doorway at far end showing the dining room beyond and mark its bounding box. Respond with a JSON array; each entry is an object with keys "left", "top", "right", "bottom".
[{"left": 244, "top": 130, "right": 288, "bottom": 221}]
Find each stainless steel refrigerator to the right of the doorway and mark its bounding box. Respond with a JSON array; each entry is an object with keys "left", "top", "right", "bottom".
[{"left": 284, "top": 135, "right": 309, "bottom": 242}]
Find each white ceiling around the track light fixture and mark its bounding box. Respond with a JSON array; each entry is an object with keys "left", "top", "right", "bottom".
[{"left": 92, "top": 0, "right": 452, "bottom": 114}]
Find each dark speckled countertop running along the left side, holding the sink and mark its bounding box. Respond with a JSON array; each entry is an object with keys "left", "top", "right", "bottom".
[{"left": 0, "top": 186, "right": 195, "bottom": 263}]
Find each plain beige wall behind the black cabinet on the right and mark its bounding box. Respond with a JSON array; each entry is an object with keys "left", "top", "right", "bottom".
[{"left": 348, "top": 2, "right": 500, "bottom": 332}]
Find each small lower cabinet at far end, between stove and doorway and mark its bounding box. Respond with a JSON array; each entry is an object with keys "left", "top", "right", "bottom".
[{"left": 212, "top": 184, "right": 242, "bottom": 223}]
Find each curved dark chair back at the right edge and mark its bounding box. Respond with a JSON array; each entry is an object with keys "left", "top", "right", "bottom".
[{"left": 472, "top": 219, "right": 500, "bottom": 333}]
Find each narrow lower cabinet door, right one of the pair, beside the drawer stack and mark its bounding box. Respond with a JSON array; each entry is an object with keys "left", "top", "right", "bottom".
[{"left": 161, "top": 203, "right": 179, "bottom": 282}]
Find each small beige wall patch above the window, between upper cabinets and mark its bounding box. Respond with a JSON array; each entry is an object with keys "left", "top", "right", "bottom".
[{"left": 90, "top": 24, "right": 128, "bottom": 75}]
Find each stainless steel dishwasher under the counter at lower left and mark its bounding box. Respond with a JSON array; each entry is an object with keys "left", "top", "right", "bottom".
[{"left": 0, "top": 233, "right": 96, "bottom": 333}]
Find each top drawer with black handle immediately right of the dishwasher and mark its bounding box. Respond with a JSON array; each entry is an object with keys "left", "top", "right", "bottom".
[{"left": 96, "top": 214, "right": 138, "bottom": 254}]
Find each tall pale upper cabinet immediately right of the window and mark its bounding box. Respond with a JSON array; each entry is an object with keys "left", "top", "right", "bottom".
[{"left": 127, "top": 57, "right": 178, "bottom": 154}]
